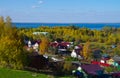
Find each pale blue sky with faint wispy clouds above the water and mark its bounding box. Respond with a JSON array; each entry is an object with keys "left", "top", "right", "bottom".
[{"left": 0, "top": 0, "right": 120, "bottom": 23}]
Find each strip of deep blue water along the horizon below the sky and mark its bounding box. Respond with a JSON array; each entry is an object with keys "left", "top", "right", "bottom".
[{"left": 12, "top": 23, "right": 120, "bottom": 30}]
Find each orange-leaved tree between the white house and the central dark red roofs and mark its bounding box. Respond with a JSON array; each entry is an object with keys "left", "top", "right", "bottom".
[{"left": 40, "top": 37, "right": 49, "bottom": 54}]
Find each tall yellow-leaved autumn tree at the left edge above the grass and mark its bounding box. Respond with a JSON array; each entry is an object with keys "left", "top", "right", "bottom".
[{"left": 0, "top": 17, "right": 27, "bottom": 69}]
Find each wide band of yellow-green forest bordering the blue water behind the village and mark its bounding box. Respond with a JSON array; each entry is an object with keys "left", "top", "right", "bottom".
[{"left": 20, "top": 26, "right": 120, "bottom": 44}]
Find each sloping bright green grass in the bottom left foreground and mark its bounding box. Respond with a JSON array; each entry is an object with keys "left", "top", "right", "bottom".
[{"left": 0, "top": 68, "right": 70, "bottom": 78}]
